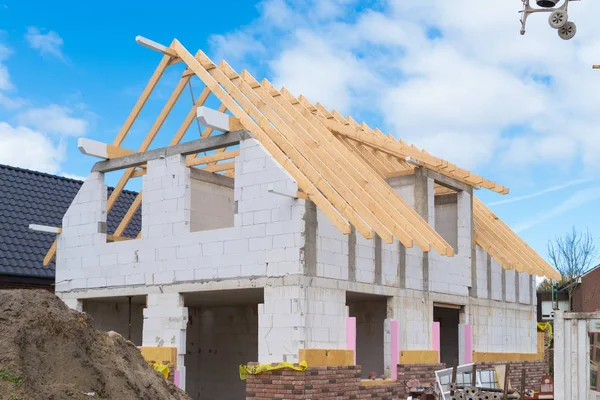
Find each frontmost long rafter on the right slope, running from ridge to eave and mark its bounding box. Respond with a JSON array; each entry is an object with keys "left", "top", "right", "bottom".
[{"left": 174, "top": 40, "right": 350, "bottom": 234}]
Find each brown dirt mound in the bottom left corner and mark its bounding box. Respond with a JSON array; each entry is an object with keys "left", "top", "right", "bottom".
[{"left": 0, "top": 290, "right": 189, "bottom": 400}]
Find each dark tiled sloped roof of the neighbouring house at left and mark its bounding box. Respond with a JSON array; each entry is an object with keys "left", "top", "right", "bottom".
[{"left": 0, "top": 164, "right": 141, "bottom": 278}]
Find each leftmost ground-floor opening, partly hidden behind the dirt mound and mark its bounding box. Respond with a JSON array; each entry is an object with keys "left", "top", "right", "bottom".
[{"left": 83, "top": 296, "right": 146, "bottom": 346}]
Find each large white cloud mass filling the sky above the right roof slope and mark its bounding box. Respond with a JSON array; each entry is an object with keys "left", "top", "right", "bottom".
[{"left": 214, "top": 0, "right": 600, "bottom": 170}]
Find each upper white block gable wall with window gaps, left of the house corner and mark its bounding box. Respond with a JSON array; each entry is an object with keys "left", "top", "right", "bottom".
[{"left": 56, "top": 139, "right": 305, "bottom": 292}]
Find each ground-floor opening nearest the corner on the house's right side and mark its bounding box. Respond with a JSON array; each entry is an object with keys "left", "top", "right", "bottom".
[{"left": 346, "top": 292, "right": 387, "bottom": 379}]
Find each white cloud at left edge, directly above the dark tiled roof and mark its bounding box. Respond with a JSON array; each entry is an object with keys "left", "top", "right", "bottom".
[{"left": 0, "top": 122, "right": 65, "bottom": 174}]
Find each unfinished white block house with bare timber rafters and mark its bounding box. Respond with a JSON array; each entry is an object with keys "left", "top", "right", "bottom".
[{"left": 43, "top": 38, "right": 558, "bottom": 400}]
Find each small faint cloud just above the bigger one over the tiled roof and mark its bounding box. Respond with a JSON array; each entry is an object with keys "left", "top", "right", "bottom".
[{"left": 17, "top": 104, "right": 88, "bottom": 136}]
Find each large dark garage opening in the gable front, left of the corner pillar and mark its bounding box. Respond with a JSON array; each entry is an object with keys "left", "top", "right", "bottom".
[{"left": 184, "top": 288, "right": 264, "bottom": 400}]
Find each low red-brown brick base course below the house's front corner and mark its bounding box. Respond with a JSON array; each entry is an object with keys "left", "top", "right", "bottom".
[{"left": 246, "top": 364, "right": 445, "bottom": 400}]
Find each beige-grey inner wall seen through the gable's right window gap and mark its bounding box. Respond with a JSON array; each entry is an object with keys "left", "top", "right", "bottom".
[{"left": 190, "top": 177, "right": 233, "bottom": 232}]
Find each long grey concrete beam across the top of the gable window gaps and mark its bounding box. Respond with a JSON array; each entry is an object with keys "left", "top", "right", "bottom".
[{"left": 92, "top": 131, "right": 247, "bottom": 172}]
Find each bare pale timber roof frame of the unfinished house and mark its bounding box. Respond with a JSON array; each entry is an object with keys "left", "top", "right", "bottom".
[{"left": 44, "top": 37, "right": 556, "bottom": 277}]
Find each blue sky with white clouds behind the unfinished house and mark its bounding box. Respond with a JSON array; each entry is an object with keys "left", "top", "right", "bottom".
[{"left": 0, "top": 0, "right": 600, "bottom": 272}]
